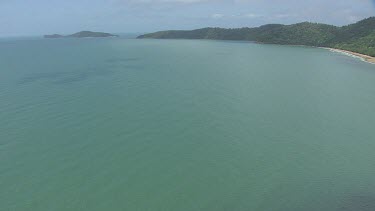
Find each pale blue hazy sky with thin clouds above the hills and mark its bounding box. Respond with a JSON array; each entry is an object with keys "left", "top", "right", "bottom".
[{"left": 0, "top": 0, "right": 375, "bottom": 36}]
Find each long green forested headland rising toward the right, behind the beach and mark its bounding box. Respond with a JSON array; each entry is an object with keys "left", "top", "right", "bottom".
[{"left": 138, "top": 17, "right": 375, "bottom": 56}]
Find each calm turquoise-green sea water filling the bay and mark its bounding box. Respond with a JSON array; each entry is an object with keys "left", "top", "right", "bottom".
[{"left": 0, "top": 38, "right": 375, "bottom": 211}]
